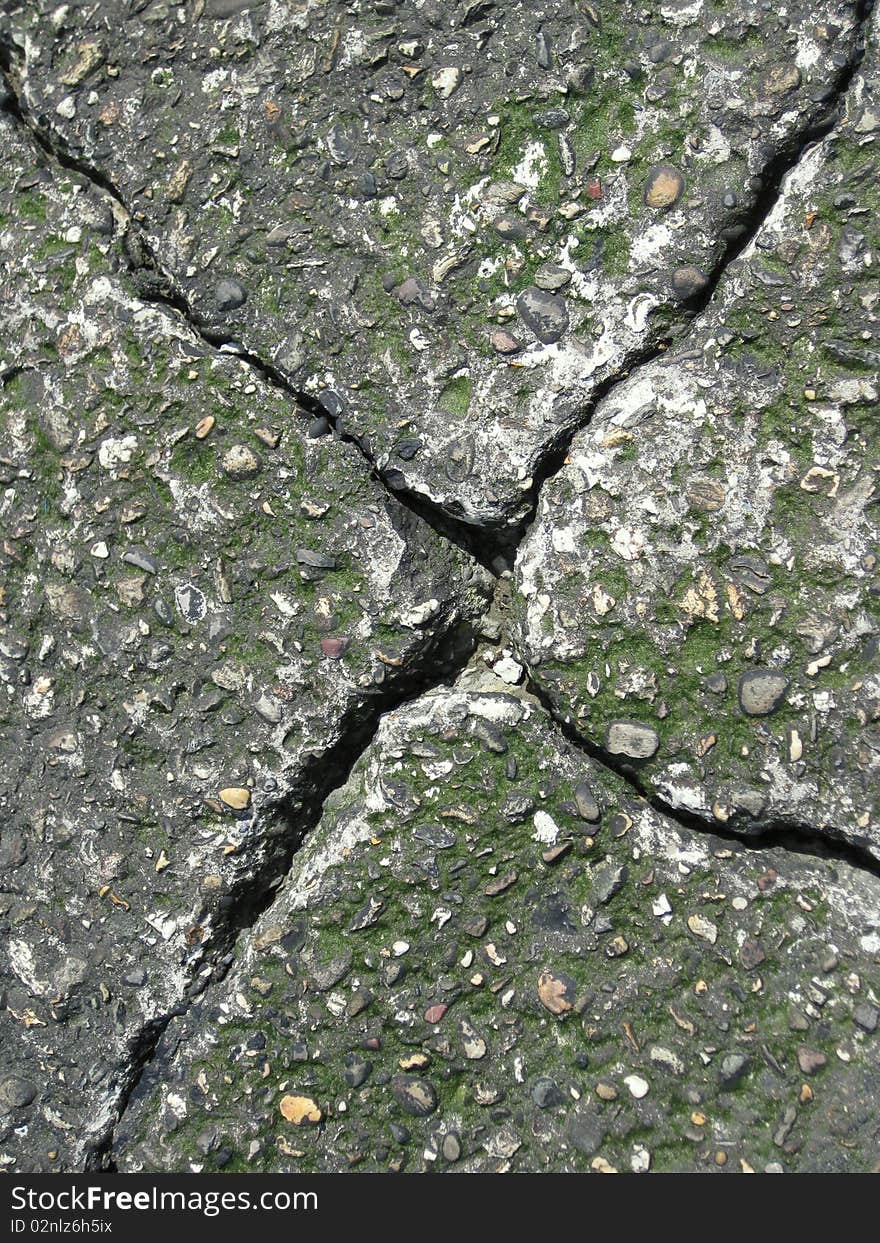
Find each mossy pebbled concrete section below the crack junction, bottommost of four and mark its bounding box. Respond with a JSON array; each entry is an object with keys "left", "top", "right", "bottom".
[{"left": 118, "top": 684, "right": 880, "bottom": 1172}]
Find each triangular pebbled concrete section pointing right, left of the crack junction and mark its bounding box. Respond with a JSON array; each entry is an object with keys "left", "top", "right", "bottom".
[{"left": 0, "top": 117, "right": 485, "bottom": 1163}]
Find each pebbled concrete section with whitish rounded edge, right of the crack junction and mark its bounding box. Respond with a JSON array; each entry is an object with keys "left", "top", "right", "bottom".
[{"left": 517, "top": 24, "right": 880, "bottom": 858}]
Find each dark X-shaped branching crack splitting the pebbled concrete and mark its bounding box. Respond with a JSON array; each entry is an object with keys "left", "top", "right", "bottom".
[{"left": 0, "top": 0, "right": 880, "bottom": 1171}]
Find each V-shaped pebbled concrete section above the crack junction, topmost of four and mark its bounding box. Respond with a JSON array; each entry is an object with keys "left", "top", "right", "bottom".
[{"left": 0, "top": 0, "right": 856, "bottom": 523}]
